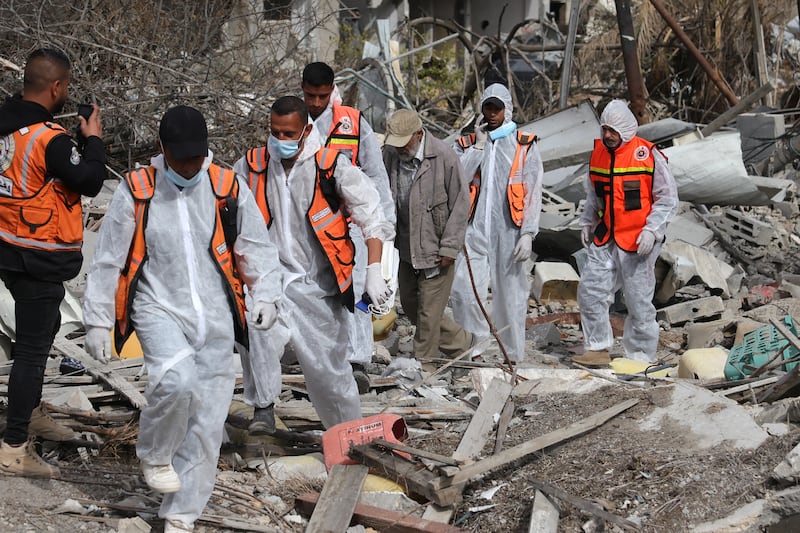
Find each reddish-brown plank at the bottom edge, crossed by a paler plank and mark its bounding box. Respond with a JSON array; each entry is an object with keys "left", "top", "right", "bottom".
[{"left": 294, "top": 493, "right": 467, "bottom": 533}]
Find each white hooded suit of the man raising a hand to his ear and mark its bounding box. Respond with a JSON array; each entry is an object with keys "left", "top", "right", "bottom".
[{"left": 450, "top": 84, "right": 543, "bottom": 362}]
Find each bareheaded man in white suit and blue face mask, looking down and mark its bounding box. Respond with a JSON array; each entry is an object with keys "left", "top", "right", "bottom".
[{"left": 234, "top": 96, "right": 394, "bottom": 434}]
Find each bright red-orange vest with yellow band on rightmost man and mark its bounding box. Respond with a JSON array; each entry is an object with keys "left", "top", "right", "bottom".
[{"left": 589, "top": 137, "right": 655, "bottom": 252}]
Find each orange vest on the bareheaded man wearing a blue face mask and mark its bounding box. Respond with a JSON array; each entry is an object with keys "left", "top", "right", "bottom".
[{"left": 246, "top": 146, "right": 355, "bottom": 312}]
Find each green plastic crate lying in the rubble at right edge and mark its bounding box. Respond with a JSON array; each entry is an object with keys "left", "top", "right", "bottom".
[{"left": 725, "top": 316, "right": 800, "bottom": 380}]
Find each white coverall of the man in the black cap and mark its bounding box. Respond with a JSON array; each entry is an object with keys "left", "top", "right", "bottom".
[{"left": 83, "top": 151, "right": 280, "bottom": 525}]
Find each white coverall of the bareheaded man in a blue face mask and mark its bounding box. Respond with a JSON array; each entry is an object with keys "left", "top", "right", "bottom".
[{"left": 234, "top": 126, "right": 394, "bottom": 427}]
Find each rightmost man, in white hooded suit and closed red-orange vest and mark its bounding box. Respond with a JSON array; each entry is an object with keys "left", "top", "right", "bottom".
[{"left": 572, "top": 100, "right": 678, "bottom": 366}]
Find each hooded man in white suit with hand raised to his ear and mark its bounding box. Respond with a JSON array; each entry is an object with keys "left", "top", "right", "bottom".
[{"left": 450, "top": 83, "right": 543, "bottom": 362}]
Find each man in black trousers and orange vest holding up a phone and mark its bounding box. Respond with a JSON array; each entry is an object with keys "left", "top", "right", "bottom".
[{"left": 0, "top": 48, "right": 106, "bottom": 477}]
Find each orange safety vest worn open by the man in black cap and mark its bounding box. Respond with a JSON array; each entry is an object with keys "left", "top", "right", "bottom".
[{"left": 114, "top": 164, "right": 248, "bottom": 352}]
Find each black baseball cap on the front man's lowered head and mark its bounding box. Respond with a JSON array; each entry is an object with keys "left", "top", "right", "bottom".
[{"left": 158, "top": 105, "right": 208, "bottom": 159}]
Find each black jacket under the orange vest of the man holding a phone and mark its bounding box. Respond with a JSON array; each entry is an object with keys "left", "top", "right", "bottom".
[{"left": 0, "top": 95, "right": 106, "bottom": 281}]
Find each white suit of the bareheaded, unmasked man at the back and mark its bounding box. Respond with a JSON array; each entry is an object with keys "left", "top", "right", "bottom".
[{"left": 313, "top": 90, "right": 396, "bottom": 365}]
